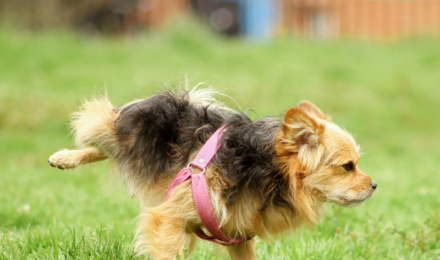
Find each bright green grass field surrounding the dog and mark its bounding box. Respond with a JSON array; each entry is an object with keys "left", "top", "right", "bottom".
[{"left": 0, "top": 21, "right": 440, "bottom": 259}]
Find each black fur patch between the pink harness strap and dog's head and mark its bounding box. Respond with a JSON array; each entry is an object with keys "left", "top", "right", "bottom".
[{"left": 217, "top": 114, "right": 291, "bottom": 210}]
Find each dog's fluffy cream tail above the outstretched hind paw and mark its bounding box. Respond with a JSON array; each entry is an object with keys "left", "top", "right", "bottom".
[{"left": 71, "top": 96, "right": 118, "bottom": 154}]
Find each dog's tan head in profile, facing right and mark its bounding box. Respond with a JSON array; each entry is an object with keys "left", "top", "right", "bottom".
[{"left": 276, "top": 101, "right": 377, "bottom": 210}]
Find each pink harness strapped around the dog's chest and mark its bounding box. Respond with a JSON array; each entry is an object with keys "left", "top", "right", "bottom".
[{"left": 165, "top": 126, "right": 246, "bottom": 246}]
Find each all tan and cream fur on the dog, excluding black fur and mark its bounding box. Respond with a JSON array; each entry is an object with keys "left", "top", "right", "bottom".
[{"left": 49, "top": 91, "right": 373, "bottom": 260}]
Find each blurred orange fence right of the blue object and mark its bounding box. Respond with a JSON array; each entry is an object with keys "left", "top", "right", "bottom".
[{"left": 282, "top": 0, "right": 440, "bottom": 39}]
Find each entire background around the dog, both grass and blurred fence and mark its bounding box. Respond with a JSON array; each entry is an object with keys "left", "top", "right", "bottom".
[{"left": 0, "top": 0, "right": 440, "bottom": 259}]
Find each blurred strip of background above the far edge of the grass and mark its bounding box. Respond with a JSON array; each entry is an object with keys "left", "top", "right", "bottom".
[{"left": 0, "top": 0, "right": 440, "bottom": 39}]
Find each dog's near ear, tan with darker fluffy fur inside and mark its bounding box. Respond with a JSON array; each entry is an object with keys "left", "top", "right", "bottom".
[{"left": 282, "top": 107, "right": 325, "bottom": 152}]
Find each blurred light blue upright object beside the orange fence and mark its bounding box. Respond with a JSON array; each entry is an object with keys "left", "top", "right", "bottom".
[{"left": 223, "top": 0, "right": 277, "bottom": 40}]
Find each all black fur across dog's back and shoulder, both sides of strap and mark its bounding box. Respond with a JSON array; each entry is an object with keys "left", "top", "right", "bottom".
[{"left": 114, "top": 91, "right": 291, "bottom": 210}]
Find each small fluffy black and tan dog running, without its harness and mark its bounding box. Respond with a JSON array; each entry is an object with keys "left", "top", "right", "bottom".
[{"left": 49, "top": 89, "right": 377, "bottom": 259}]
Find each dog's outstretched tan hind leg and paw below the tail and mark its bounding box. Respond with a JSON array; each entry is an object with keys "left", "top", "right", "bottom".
[{"left": 48, "top": 147, "right": 108, "bottom": 170}]
